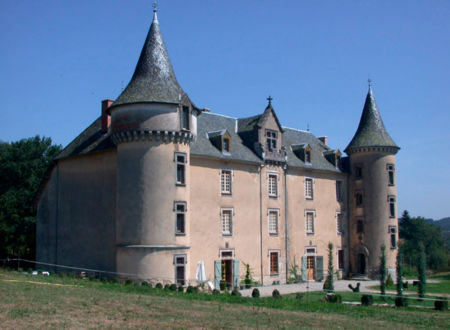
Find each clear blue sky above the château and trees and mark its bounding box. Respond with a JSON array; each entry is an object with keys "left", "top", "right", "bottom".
[{"left": 0, "top": 0, "right": 450, "bottom": 219}]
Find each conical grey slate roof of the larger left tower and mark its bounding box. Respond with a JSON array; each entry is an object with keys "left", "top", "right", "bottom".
[{"left": 112, "top": 11, "right": 189, "bottom": 107}]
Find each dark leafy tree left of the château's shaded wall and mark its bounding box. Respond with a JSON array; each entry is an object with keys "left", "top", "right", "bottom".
[{"left": 0, "top": 136, "right": 61, "bottom": 259}]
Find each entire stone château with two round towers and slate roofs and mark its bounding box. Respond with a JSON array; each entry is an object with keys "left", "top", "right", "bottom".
[{"left": 37, "top": 12, "right": 399, "bottom": 286}]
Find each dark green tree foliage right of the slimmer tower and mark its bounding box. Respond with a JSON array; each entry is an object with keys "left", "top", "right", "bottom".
[{"left": 399, "top": 211, "right": 447, "bottom": 270}]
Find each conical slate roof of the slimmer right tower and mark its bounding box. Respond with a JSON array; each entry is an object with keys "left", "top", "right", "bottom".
[{"left": 345, "top": 87, "right": 400, "bottom": 154}]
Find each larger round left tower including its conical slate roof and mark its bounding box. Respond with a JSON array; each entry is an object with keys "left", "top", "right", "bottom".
[{"left": 110, "top": 9, "right": 198, "bottom": 284}]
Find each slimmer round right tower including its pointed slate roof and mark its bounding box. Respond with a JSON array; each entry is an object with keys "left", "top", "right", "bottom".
[{"left": 345, "top": 81, "right": 400, "bottom": 277}]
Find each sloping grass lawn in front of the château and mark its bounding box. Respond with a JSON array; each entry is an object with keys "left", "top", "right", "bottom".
[{"left": 0, "top": 269, "right": 450, "bottom": 329}]
